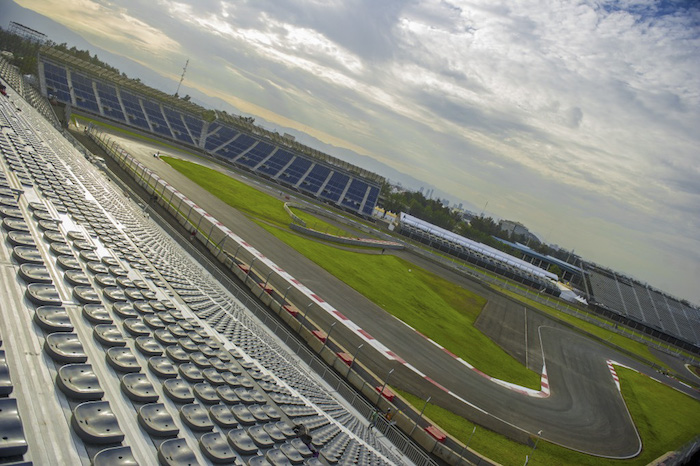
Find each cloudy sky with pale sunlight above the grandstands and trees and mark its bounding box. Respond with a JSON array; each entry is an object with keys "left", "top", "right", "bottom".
[{"left": 6, "top": 0, "right": 700, "bottom": 303}]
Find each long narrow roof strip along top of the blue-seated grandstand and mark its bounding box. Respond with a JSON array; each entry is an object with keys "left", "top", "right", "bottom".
[{"left": 39, "top": 46, "right": 386, "bottom": 185}]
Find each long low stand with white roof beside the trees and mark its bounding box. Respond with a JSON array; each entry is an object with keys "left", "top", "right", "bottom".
[{"left": 398, "top": 212, "right": 561, "bottom": 296}]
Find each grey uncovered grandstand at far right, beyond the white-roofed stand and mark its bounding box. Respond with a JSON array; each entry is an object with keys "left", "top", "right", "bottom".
[{"left": 583, "top": 262, "right": 700, "bottom": 352}]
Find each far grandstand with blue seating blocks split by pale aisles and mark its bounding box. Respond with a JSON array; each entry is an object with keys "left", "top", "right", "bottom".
[{"left": 39, "top": 47, "right": 384, "bottom": 217}]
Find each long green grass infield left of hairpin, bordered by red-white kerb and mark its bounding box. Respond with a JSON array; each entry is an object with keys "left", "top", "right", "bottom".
[{"left": 163, "top": 157, "right": 540, "bottom": 389}]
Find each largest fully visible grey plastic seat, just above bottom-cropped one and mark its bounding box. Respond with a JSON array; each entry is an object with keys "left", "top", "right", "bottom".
[{"left": 71, "top": 401, "right": 124, "bottom": 444}]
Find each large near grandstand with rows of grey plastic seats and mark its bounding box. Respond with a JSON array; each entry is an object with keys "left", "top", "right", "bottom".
[{"left": 0, "top": 62, "right": 410, "bottom": 465}]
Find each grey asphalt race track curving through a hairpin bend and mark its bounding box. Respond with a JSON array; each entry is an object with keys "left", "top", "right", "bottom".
[{"left": 85, "top": 123, "right": 698, "bottom": 458}]
